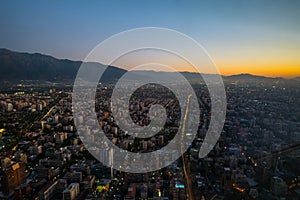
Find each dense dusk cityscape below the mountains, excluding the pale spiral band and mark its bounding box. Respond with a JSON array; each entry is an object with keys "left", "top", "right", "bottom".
[{"left": 0, "top": 79, "right": 300, "bottom": 200}]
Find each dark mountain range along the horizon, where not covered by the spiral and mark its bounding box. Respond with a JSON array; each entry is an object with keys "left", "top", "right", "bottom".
[{"left": 0, "top": 49, "right": 300, "bottom": 82}]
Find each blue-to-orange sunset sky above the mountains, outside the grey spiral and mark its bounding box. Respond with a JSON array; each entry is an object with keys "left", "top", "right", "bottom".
[{"left": 0, "top": 0, "right": 300, "bottom": 77}]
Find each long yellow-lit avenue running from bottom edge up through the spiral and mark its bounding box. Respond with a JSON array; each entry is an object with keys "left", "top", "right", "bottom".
[{"left": 181, "top": 94, "right": 193, "bottom": 200}]
